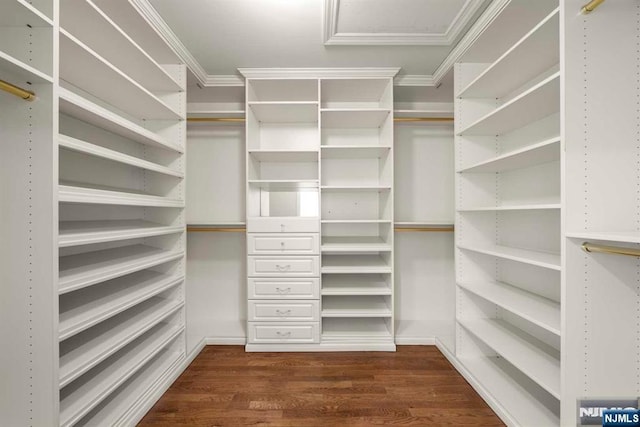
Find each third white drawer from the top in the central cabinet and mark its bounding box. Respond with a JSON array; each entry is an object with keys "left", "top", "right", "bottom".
[{"left": 247, "top": 255, "right": 320, "bottom": 277}]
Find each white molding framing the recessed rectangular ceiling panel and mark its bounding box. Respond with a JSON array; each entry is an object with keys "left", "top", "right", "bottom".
[{"left": 322, "top": 0, "right": 484, "bottom": 46}]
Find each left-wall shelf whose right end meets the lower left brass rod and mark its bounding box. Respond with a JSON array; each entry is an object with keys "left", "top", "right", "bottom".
[{"left": 58, "top": 220, "right": 185, "bottom": 247}]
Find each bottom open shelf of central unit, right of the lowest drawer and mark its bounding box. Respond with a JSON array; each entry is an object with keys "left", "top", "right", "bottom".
[{"left": 322, "top": 317, "right": 392, "bottom": 342}]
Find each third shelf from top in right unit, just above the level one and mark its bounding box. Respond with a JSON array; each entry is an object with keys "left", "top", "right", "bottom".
[{"left": 458, "top": 137, "right": 560, "bottom": 173}]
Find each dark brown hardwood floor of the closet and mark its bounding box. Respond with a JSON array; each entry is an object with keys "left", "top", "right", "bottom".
[{"left": 139, "top": 346, "right": 504, "bottom": 427}]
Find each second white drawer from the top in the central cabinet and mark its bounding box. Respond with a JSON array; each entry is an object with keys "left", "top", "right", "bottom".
[{"left": 247, "top": 233, "right": 320, "bottom": 255}]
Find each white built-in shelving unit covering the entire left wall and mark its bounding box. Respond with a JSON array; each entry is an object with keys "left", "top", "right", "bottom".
[{"left": 0, "top": 0, "right": 186, "bottom": 426}]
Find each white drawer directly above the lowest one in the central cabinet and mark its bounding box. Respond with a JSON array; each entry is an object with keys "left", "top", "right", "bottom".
[{"left": 249, "top": 300, "right": 320, "bottom": 322}]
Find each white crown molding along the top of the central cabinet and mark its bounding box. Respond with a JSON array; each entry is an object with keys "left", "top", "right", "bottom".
[{"left": 238, "top": 67, "right": 400, "bottom": 79}]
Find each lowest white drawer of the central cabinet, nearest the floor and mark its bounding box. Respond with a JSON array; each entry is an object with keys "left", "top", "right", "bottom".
[{"left": 247, "top": 322, "right": 320, "bottom": 344}]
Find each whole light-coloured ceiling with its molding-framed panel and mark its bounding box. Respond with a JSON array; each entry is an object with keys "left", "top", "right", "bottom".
[{"left": 147, "top": 0, "right": 490, "bottom": 85}]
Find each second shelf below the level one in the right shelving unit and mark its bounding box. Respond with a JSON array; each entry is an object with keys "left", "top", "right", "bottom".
[{"left": 458, "top": 282, "right": 561, "bottom": 336}]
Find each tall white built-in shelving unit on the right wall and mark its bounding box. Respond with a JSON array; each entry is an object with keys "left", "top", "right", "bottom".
[{"left": 455, "top": 2, "right": 560, "bottom": 425}]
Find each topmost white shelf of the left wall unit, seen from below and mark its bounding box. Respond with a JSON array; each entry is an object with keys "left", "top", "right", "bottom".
[{"left": 60, "top": 0, "right": 182, "bottom": 92}]
